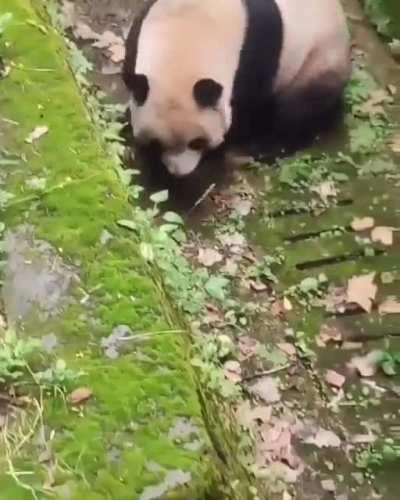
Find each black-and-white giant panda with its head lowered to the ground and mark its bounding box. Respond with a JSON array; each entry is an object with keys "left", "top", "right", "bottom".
[{"left": 123, "top": 0, "right": 351, "bottom": 177}]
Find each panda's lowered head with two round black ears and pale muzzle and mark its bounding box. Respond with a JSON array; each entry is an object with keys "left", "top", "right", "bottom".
[{"left": 126, "top": 74, "right": 231, "bottom": 177}]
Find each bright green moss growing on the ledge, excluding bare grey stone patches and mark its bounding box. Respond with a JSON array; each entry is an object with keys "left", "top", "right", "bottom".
[{"left": 0, "top": 0, "right": 219, "bottom": 500}]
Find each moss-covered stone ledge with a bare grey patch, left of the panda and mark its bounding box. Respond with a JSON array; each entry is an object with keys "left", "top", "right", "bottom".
[{"left": 0, "top": 0, "right": 225, "bottom": 500}]
